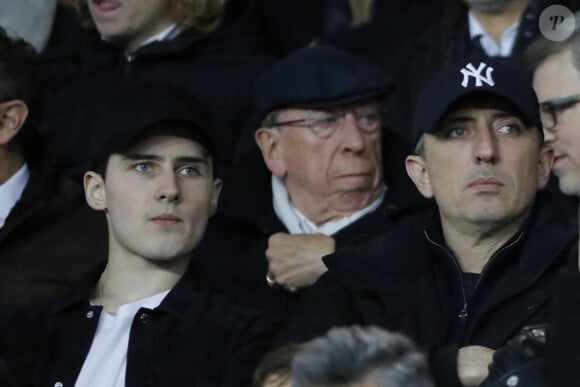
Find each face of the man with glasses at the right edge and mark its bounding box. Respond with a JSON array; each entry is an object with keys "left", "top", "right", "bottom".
[{"left": 534, "top": 49, "right": 580, "bottom": 196}]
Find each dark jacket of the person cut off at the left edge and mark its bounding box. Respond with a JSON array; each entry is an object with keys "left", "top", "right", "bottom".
[{"left": 0, "top": 138, "right": 108, "bottom": 304}]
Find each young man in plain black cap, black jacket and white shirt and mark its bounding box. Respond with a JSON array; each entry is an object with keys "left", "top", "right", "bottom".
[{"left": 0, "top": 84, "right": 271, "bottom": 387}]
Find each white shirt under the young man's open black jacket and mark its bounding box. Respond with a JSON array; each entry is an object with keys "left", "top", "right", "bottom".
[{"left": 75, "top": 290, "right": 169, "bottom": 387}]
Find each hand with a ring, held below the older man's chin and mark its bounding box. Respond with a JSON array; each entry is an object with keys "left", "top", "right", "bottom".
[{"left": 266, "top": 233, "right": 335, "bottom": 291}]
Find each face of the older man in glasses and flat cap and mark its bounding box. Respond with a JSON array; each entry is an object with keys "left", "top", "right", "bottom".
[{"left": 256, "top": 101, "right": 382, "bottom": 224}]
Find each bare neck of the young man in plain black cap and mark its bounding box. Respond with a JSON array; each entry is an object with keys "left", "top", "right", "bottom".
[{"left": 92, "top": 257, "right": 189, "bottom": 315}]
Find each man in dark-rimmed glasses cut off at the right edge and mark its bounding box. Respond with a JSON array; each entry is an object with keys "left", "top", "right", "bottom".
[{"left": 478, "top": 13, "right": 580, "bottom": 387}]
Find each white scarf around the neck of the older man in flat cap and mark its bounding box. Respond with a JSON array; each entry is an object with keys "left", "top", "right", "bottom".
[{"left": 272, "top": 175, "right": 387, "bottom": 236}]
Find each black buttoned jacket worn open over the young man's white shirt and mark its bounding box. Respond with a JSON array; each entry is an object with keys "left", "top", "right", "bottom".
[{"left": 0, "top": 267, "right": 275, "bottom": 387}]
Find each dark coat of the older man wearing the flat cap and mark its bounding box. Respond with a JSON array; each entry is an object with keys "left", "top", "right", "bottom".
[{"left": 195, "top": 136, "right": 430, "bottom": 318}]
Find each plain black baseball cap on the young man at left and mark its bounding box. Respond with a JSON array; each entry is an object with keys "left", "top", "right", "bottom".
[{"left": 88, "top": 82, "right": 218, "bottom": 169}]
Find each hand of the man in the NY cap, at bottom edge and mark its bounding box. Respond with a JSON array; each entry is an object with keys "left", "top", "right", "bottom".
[{"left": 457, "top": 345, "right": 493, "bottom": 387}]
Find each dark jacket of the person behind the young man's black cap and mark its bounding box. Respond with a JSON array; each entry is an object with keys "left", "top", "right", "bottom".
[{"left": 42, "top": 23, "right": 272, "bottom": 173}]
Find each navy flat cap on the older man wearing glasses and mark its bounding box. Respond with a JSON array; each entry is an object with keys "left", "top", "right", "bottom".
[{"left": 254, "top": 46, "right": 393, "bottom": 125}]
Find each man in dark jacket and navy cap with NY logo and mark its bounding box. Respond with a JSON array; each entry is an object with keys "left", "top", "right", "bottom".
[{"left": 278, "top": 58, "right": 576, "bottom": 386}]
